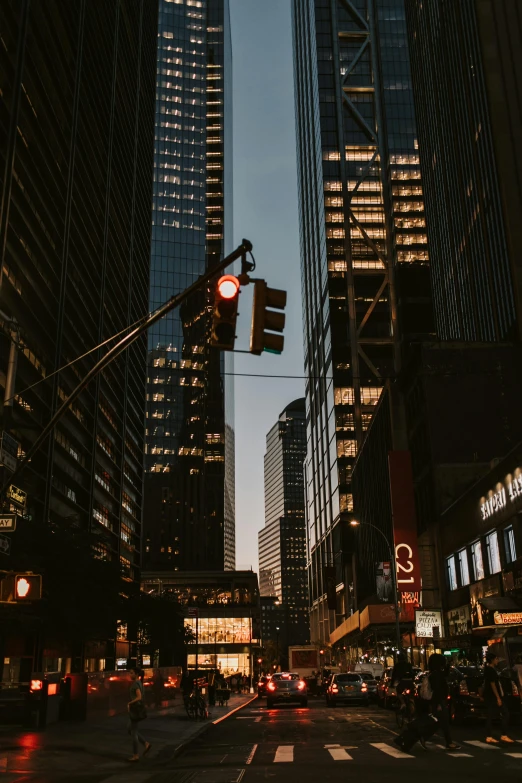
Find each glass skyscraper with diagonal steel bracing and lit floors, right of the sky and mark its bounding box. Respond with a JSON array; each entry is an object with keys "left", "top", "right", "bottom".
[{"left": 292, "top": 0, "right": 432, "bottom": 640}]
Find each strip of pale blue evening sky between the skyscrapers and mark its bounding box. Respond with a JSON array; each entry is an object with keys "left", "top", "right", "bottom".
[{"left": 230, "top": 0, "right": 304, "bottom": 570}]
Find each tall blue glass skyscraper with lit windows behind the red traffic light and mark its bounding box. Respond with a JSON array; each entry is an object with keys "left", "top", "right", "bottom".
[{"left": 144, "top": 0, "right": 235, "bottom": 571}]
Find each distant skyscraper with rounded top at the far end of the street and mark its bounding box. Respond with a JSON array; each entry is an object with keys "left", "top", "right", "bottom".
[{"left": 259, "top": 399, "right": 310, "bottom": 645}]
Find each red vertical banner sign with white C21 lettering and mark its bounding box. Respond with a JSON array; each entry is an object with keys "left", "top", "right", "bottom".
[{"left": 388, "top": 451, "right": 421, "bottom": 593}]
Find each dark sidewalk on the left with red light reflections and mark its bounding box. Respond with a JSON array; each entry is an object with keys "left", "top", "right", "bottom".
[{"left": 0, "top": 694, "right": 255, "bottom": 783}]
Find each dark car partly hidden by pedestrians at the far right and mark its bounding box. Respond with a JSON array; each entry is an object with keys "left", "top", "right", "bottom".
[{"left": 448, "top": 666, "right": 521, "bottom": 723}]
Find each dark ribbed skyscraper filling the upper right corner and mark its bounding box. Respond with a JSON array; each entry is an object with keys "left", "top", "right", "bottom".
[{"left": 406, "top": 0, "right": 522, "bottom": 341}]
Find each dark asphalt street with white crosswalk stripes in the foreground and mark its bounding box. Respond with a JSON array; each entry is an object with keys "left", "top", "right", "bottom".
[{"left": 0, "top": 699, "right": 522, "bottom": 783}]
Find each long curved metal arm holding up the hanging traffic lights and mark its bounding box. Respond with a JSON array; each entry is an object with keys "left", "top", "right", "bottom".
[{"left": 0, "top": 239, "right": 252, "bottom": 499}]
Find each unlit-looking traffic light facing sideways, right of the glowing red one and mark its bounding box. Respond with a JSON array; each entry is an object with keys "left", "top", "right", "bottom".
[{"left": 250, "top": 280, "right": 286, "bottom": 356}]
